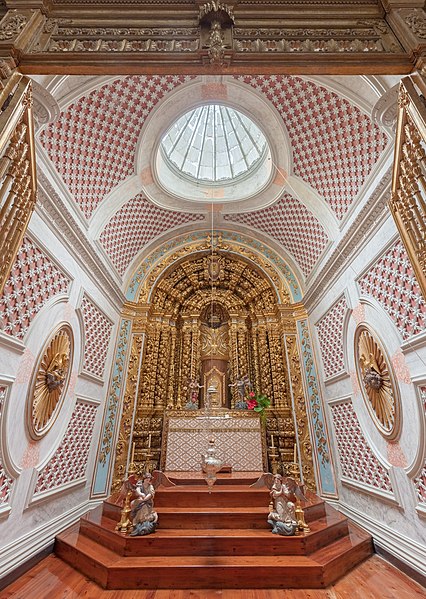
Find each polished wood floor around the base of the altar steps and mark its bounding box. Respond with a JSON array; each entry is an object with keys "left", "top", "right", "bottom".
[{"left": 0, "top": 555, "right": 426, "bottom": 599}]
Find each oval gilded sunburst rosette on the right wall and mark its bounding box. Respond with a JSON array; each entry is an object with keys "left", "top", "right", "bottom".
[{"left": 355, "top": 324, "right": 401, "bottom": 440}]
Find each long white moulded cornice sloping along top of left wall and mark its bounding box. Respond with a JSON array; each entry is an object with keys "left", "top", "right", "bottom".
[{"left": 36, "top": 171, "right": 125, "bottom": 311}]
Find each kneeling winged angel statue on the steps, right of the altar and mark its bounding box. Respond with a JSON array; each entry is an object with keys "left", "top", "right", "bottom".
[{"left": 251, "top": 472, "right": 306, "bottom": 536}]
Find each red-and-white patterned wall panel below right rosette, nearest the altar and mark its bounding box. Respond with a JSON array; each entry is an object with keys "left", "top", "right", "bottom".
[{"left": 331, "top": 401, "right": 393, "bottom": 493}]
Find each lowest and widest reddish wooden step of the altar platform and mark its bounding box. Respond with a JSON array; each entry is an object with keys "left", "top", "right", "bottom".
[{"left": 55, "top": 531, "right": 371, "bottom": 589}]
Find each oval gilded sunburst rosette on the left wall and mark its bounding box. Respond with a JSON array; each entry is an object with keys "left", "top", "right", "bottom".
[{"left": 27, "top": 324, "right": 74, "bottom": 440}]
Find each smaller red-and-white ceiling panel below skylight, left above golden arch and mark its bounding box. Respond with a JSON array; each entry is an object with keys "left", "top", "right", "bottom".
[{"left": 99, "top": 194, "right": 205, "bottom": 275}]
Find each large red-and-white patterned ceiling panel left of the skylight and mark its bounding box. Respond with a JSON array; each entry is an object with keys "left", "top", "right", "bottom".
[{"left": 40, "top": 75, "right": 191, "bottom": 219}]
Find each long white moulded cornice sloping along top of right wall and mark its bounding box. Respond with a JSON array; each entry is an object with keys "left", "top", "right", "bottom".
[{"left": 303, "top": 167, "right": 392, "bottom": 313}]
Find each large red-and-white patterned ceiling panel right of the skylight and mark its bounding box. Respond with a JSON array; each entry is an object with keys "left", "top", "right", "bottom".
[{"left": 237, "top": 75, "right": 388, "bottom": 220}]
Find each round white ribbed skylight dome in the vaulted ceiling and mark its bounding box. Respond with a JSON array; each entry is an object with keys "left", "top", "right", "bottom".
[{"left": 156, "top": 103, "right": 271, "bottom": 201}]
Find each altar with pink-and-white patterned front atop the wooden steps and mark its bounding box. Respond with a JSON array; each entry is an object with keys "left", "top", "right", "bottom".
[{"left": 162, "top": 410, "right": 265, "bottom": 472}]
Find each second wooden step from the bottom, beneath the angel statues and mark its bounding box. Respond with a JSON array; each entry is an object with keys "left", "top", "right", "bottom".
[{"left": 80, "top": 510, "right": 348, "bottom": 556}]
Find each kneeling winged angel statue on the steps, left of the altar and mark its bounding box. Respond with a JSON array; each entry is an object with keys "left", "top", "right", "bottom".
[{"left": 116, "top": 470, "right": 174, "bottom": 537}]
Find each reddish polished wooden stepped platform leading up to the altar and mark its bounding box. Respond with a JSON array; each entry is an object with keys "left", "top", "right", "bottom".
[{"left": 55, "top": 472, "right": 372, "bottom": 589}]
